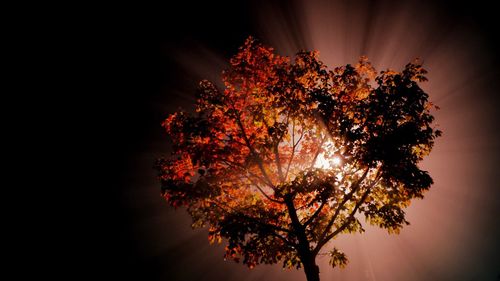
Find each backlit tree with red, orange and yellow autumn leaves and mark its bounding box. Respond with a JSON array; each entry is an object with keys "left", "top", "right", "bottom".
[{"left": 157, "top": 38, "right": 441, "bottom": 281}]
